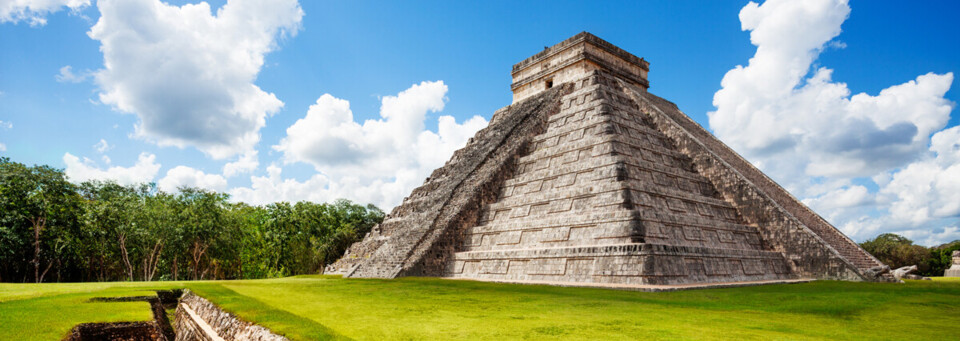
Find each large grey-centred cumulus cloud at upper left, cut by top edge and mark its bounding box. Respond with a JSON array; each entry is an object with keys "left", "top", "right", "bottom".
[{"left": 89, "top": 0, "right": 303, "bottom": 159}]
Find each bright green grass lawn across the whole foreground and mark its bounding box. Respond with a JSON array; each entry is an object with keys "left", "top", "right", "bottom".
[{"left": 0, "top": 276, "right": 960, "bottom": 340}]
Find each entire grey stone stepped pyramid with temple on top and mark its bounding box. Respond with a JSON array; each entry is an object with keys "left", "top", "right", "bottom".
[{"left": 327, "top": 32, "right": 889, "bottom": 290}]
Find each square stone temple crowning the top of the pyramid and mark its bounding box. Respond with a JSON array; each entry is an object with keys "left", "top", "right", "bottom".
[{"left": 510, "top": 32, "right": 650, "bottom": 103}]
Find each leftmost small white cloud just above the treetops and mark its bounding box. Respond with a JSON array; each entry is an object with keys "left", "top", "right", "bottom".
[{"left": 63, "top": 153, "right": 160, "bottom": 185}]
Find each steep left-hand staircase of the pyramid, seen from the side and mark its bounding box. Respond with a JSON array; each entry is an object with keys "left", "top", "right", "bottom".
[{"left": 327, "top": 81, "right": 570, "bottom": 278}]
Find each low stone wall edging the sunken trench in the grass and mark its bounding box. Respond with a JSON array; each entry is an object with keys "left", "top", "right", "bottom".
[{"left": 174, "top": 290, "right": 287, "bottom": 341}]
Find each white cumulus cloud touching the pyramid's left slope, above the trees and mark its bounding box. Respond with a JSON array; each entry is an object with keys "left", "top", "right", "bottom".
[{"left": 231, "top": 81, "right": 487, "bottom": 209}]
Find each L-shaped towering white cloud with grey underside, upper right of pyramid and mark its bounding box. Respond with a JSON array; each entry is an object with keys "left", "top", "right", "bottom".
[{"left": 709, "top": 0, "right": 953, "bottom": 182}]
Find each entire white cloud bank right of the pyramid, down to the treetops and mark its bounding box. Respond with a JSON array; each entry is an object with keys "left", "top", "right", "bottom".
[{"left": 708, "top": 0, "right": 960, "bottom": 243}]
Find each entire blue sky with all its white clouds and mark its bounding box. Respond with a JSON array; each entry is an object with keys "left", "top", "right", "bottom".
[{"left": 0, "top": 0, "right": 960, "bottom": 244}]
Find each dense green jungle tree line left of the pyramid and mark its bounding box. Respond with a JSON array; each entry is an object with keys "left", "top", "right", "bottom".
[{"left": 0, "top": 157, "right": 384, "bottom": 283}]
